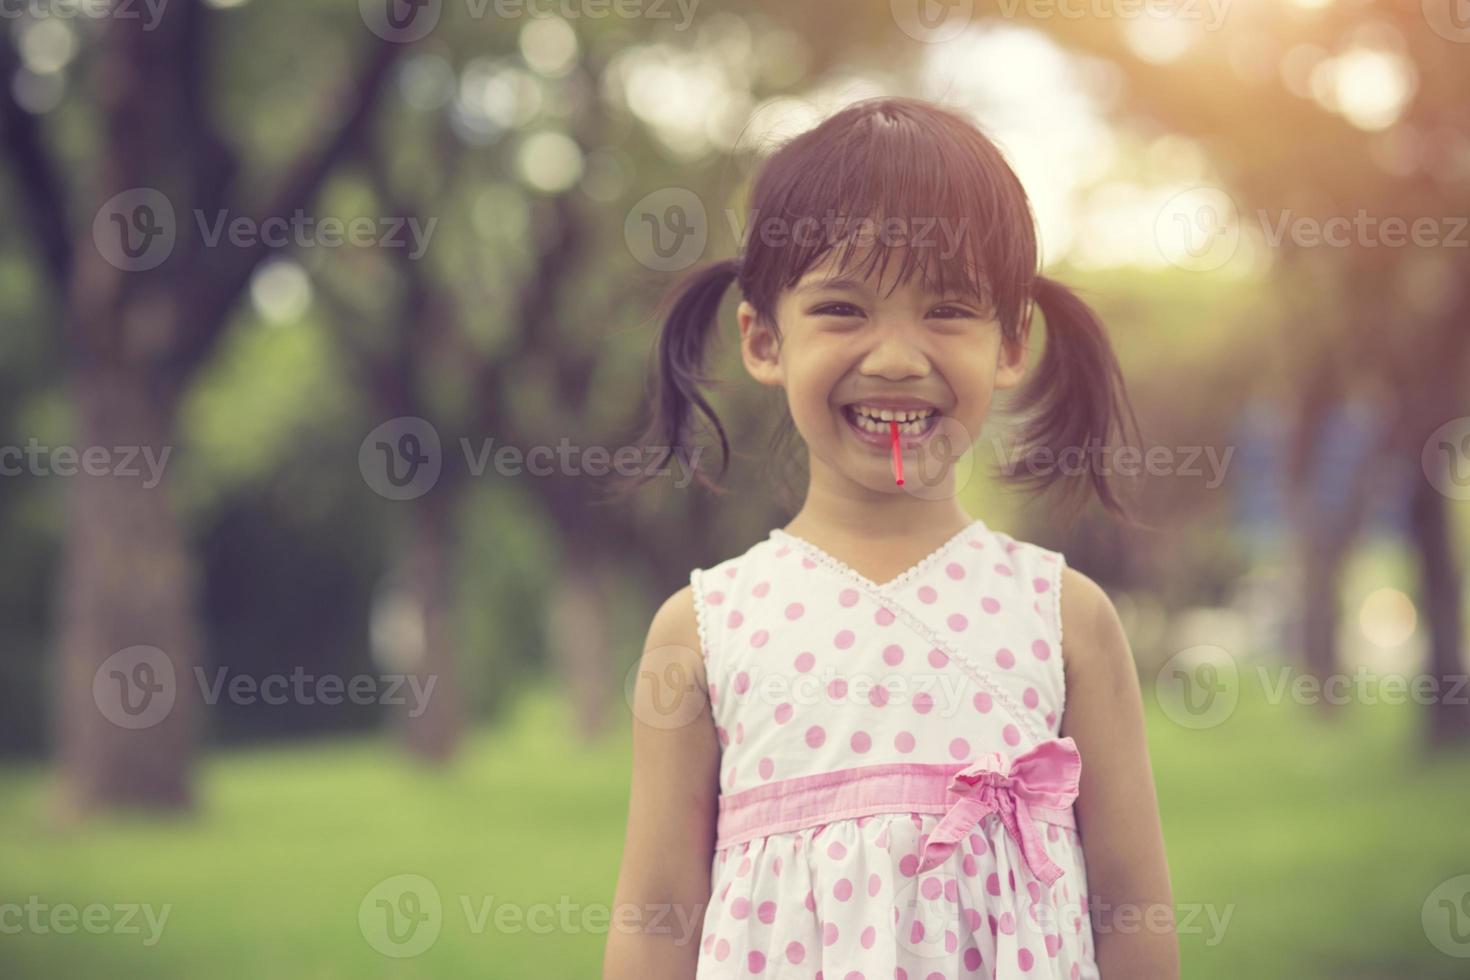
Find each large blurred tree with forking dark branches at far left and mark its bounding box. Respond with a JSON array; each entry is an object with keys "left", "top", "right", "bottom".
[{"left": 0, "top": 9, "right": 403, "bottom": 813}]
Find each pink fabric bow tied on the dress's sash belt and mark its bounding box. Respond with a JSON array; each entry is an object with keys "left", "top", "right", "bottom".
[{"left": 919, "top": 738, "right": 1082, "bottom": 884}]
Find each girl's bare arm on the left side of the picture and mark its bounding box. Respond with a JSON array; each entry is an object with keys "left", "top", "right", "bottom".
[{"left": 603, "top": 586, "right": 720, "bottom": 980}]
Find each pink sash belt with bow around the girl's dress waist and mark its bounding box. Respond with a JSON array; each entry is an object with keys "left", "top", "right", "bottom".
[{"left": 716, "top": 738, "right": 1082, "bottom": 884}]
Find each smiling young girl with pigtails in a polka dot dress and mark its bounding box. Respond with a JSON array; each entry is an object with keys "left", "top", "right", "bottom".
[{"left": 604, "top": 98, "right": 1179, "bottom": 980}]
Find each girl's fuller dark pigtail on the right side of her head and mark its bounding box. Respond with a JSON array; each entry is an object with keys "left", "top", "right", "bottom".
[{"left": 1005, "top": 276, "right": 1138, "bottom": 523}]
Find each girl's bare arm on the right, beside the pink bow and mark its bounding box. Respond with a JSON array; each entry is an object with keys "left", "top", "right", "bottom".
[{"left": 1061, "top": 567, "right": 1179, "bottom": 980}]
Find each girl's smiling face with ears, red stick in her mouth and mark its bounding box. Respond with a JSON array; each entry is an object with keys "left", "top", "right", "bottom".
[{"left": 739, "top": 254, "right": 1026, "bottom": 494}]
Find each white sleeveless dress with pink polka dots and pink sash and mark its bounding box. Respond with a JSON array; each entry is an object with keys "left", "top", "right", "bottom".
[{"left": 689, "top": 520, "right": 1098, "bottom": 980}]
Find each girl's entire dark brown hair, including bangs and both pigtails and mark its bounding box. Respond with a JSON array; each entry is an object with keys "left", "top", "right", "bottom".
[{"left": 605, "top": 97, "right": 1138, "bottom": 520}]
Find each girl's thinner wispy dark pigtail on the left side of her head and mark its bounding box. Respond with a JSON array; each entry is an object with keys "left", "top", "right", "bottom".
[{"left": 602, "top": 259, "right": 741, "bottom": 497}]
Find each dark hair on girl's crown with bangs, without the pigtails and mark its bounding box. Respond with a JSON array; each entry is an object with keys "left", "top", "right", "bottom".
[{"left": 747, "top": 100, "right": 1036, "bottom": 328}]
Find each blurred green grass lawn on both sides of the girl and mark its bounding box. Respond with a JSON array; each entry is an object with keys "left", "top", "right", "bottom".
[{"left": 0, "top": 675, "right": 1470, "bottom": 980}]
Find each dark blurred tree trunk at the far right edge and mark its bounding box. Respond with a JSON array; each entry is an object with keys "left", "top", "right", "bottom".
[{"left": 1408, "top": 455, "right": 1470, "bottom": 751}]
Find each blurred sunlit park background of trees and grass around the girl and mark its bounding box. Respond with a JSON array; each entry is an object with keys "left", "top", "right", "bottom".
[{"left": 0, "top": 0, "right": 1470, "bottom": 980}]
